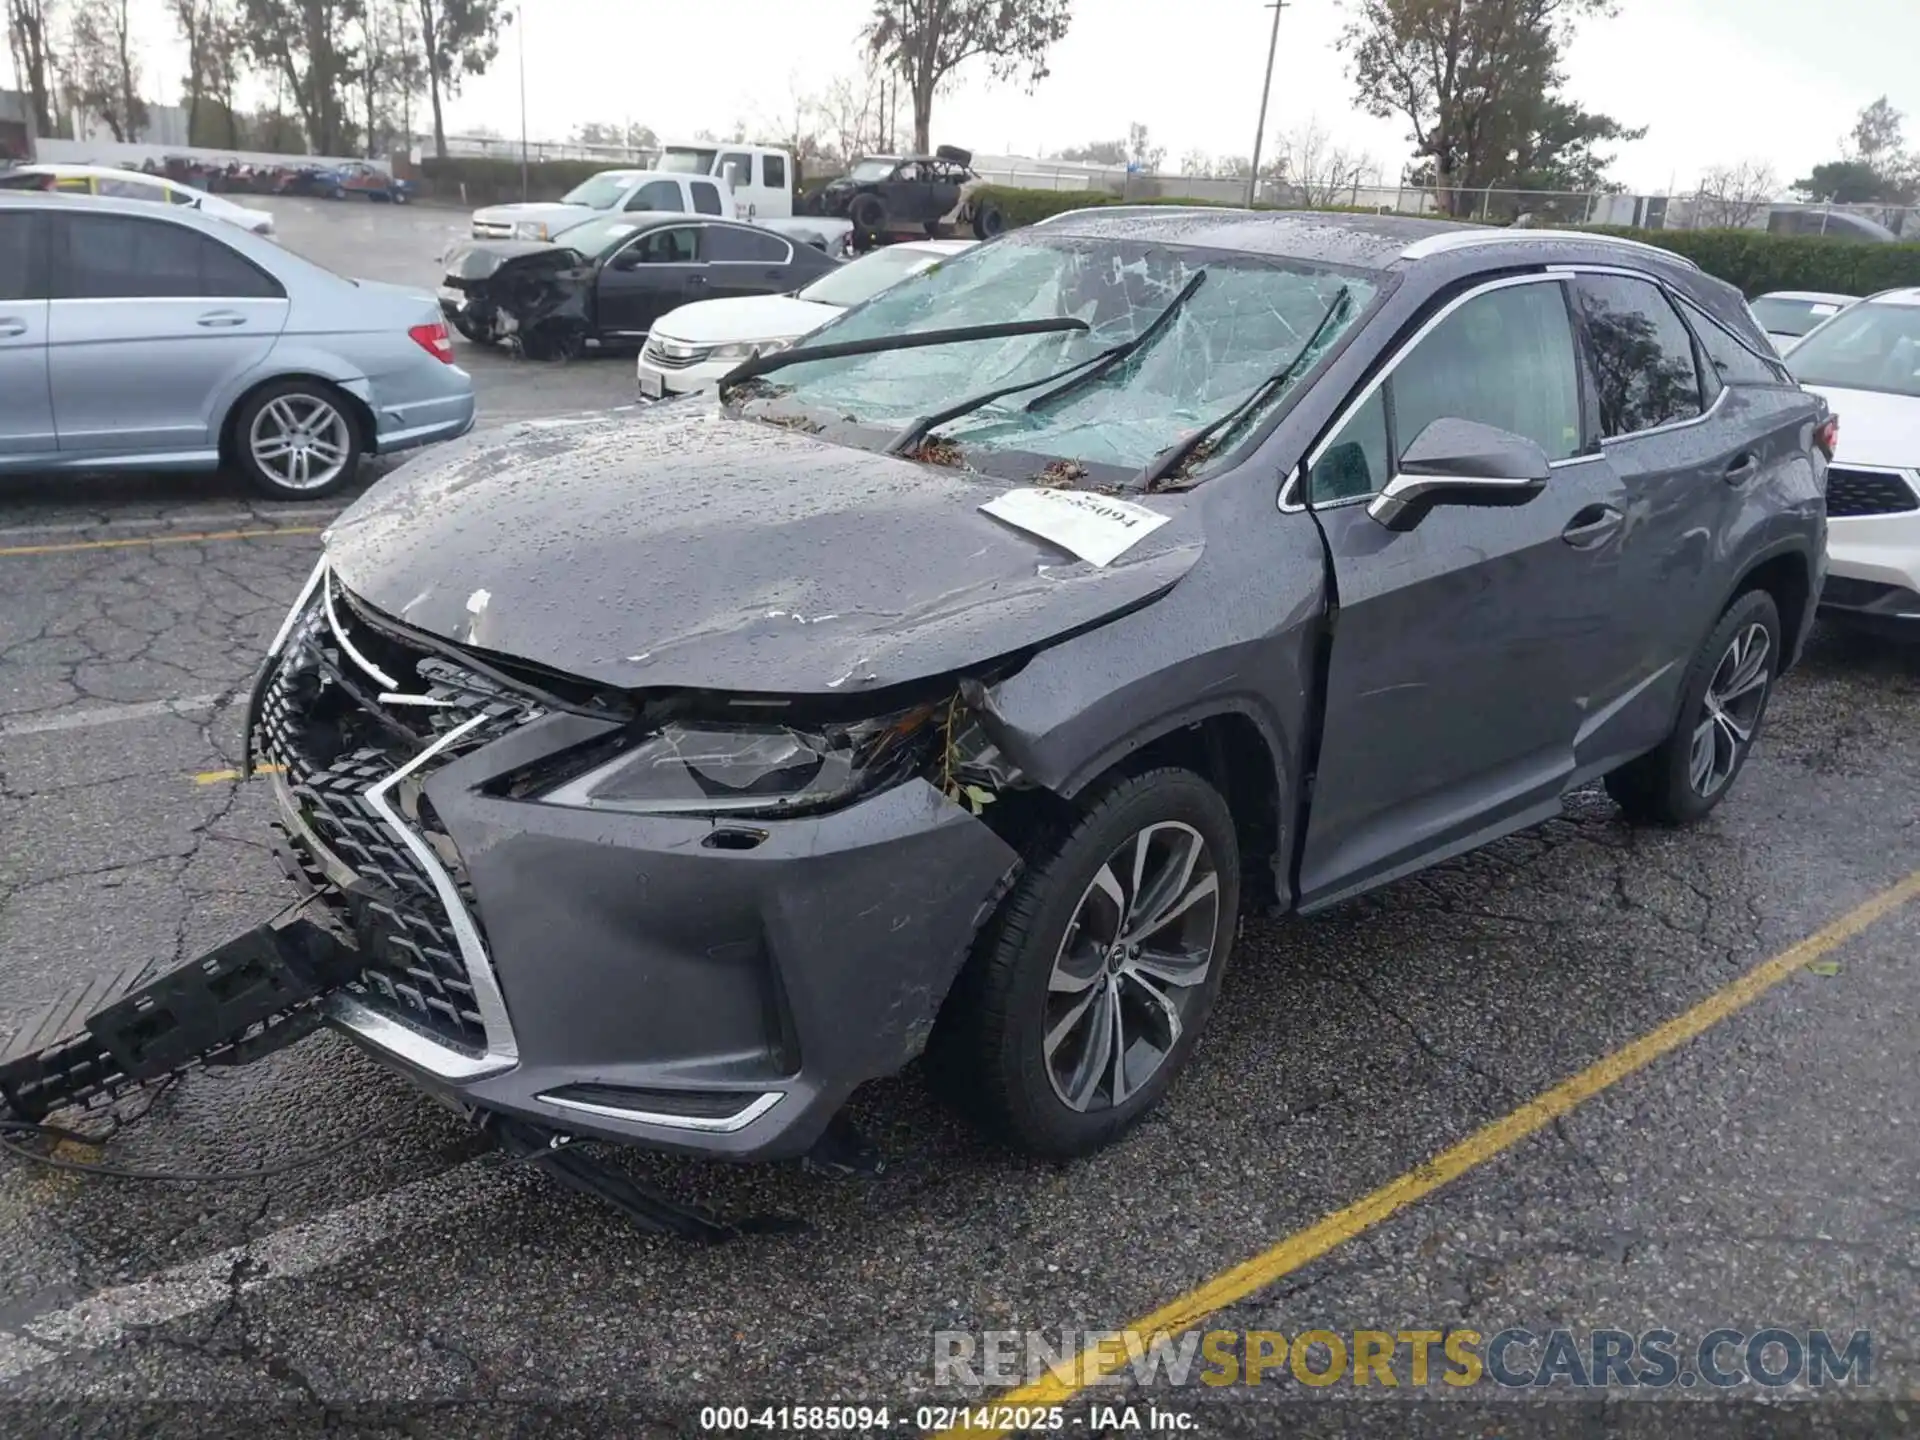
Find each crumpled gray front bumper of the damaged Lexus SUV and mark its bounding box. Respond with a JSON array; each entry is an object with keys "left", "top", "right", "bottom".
[{"left": 275, "top": 714, "right": 1016, "bottom": 1158}]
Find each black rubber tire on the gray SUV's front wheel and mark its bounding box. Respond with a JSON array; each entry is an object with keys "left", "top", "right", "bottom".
[{"left": 929, "top": 768, "right": 1240, "bottom": 1158}]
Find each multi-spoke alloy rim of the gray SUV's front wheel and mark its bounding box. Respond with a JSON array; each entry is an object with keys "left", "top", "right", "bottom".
[{"left": 1041, "top": 822, "right": 1219, "bottom": 1112}]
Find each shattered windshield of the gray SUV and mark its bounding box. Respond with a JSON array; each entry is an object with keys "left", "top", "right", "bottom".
[{"left": 737, "top": 234, "right": 1379, "bottom": 480}]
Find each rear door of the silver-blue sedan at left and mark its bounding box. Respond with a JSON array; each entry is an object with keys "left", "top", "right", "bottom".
[{"left": 48, "top": 213, "right": 288, "bottom": 451}]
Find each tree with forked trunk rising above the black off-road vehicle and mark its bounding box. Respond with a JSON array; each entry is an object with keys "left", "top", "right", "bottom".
[{"left": 866, "top": 0, "right": 1069, "bottom": 154}]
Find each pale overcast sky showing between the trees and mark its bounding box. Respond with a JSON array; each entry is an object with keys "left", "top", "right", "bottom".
[{"left": 78, "top": 0, "right": 1920, "bottom": 192}]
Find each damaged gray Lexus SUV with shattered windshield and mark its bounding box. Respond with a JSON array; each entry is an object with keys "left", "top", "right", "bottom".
[{"left": 250, "top": 209, "right": 1832, "bottom": 1158}]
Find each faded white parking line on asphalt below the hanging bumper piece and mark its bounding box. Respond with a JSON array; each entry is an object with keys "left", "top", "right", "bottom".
[{"left": 0, "top": 1156, "right": 515, "bottom": 1384}]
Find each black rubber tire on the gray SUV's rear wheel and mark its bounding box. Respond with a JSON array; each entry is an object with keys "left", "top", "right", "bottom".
[{"left": 1607, "top": 589, "right": 1784, "bottom": 826}]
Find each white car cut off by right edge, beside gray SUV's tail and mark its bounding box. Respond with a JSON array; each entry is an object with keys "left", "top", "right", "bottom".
[{"left": 1788, "top": 288, "right": 1920, "bottom": 639}]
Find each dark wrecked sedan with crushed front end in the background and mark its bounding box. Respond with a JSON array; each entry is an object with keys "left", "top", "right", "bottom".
[{"left": 440, "top": 215, "right": 839, "bottom": 359}]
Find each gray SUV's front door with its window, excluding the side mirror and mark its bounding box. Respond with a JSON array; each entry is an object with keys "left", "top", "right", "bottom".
[{"left": 1300, "top": 276, "right": 1634, "bottom": 908}]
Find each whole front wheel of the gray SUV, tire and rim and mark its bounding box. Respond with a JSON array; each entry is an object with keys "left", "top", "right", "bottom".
[{"left": 931, "top": 768, "right": 1240, "bottom": 1156}]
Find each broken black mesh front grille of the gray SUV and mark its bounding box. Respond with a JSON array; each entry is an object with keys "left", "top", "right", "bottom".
[{"left": 255, "top": 576, "right": 541, "bottom": 1054}]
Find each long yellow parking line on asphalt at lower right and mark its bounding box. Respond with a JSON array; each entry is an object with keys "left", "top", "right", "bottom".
[{"left": 945, "top": 870, "right": 1920, "bottom": 1434}]
